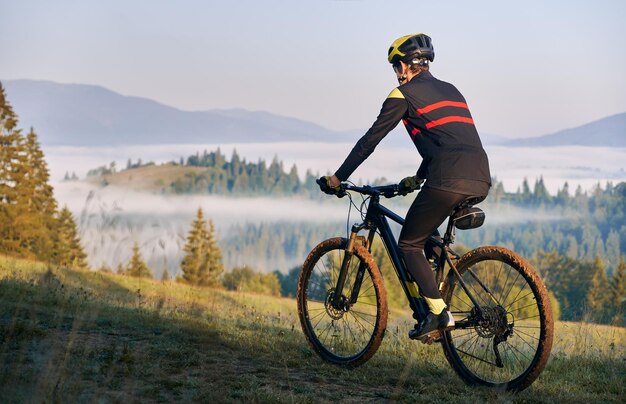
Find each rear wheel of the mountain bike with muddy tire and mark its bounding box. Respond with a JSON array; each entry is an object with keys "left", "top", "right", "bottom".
[{"left": 442, "top": 247, "right": 554, "bottom": 391}]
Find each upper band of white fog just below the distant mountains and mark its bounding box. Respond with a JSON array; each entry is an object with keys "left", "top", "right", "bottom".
[{"left": 44, "top": 139, "right": 626, "bottom": 194}]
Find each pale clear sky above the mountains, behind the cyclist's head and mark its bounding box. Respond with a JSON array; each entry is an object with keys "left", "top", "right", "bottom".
[{"left": 0, "top": 0, "right": 626, "bottom": 137}]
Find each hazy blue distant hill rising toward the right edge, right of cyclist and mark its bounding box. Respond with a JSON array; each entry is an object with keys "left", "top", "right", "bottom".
[{"left": 505, "top": 112, "right": 626, "bottom": 147}]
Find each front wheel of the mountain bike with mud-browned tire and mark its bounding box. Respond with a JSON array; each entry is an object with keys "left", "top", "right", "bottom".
[{"left": 297, "top": 237, "right": 388, "bottom": 367}]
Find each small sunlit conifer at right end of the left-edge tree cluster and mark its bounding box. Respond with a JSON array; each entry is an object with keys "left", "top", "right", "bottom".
[{"left": 53, "top": 206, "right": 87, "bottom": 269}]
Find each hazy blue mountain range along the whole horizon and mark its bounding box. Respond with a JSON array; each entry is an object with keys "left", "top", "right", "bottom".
[{"left": 2, "top": 80, "right": 626, "bottom": 147}]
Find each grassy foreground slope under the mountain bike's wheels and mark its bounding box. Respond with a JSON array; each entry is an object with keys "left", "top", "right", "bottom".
[{"left": 0, "top": 257, "right": 626, "bottom": 402}]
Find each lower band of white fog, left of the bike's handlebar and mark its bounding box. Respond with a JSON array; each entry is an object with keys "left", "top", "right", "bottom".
[{"left": 55, "top": 182, "right": 348, "bottom": 276}]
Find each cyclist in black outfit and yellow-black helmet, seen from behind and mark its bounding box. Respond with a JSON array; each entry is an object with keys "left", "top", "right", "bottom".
[{"left": 324, "top": 33, "right": 491, "bottom": 341}]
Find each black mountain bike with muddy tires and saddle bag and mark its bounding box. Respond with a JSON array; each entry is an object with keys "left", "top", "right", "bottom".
[{"left": 297, "top": 183, "right": 553, "bottom": 391}]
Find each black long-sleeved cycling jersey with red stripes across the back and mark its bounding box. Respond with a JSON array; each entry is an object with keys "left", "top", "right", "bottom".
[{"left": 335, "top": 71, "right": 491, "bottom": 196}]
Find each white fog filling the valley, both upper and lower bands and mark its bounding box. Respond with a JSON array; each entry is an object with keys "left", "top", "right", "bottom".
[{"left": 44, "top": 142, "right": 626, "bottom": 276}]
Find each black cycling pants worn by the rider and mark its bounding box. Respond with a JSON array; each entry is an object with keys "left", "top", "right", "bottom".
[{"left": 398, "top": 186, "right": 471, "bottom": 299}]
